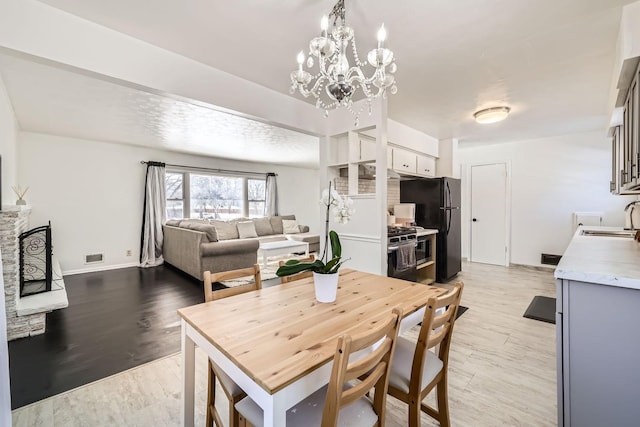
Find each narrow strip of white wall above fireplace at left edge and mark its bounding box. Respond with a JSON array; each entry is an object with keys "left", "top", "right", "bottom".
[{"left": 0, "top": 76, "right": 19, "bottom": 204}]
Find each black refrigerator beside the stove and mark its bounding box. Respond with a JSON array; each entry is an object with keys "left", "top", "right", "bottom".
[{"left": 400, "top": 177, "right": 462, "bottom": 283}]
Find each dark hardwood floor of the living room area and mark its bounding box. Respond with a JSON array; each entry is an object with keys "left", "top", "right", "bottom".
[{"left": 9, "top": 266, "right": 204, "bottom": 409}]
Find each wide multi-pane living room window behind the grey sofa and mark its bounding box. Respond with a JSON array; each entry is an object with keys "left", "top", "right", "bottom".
[{"left": 166, "top": 171, "right": 266, "bottom": 220}]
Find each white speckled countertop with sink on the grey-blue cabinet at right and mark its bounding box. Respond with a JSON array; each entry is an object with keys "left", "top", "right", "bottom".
[{"left": 555, "top": 227, "right": 640, "bottom": 289}]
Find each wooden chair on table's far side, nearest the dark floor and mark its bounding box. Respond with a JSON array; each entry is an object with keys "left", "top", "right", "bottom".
[{"left": 204, "top": 264, "right": 262, "bottom": 427}]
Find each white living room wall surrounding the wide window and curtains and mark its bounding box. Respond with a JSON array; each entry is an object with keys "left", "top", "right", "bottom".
[{"left": 19, "top": 132, "right": 321, "bottom": 273}]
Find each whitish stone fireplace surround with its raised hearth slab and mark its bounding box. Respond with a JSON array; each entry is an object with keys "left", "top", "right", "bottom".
[{"left": 0, "top": 206, "right": 69, "bottom": 341}]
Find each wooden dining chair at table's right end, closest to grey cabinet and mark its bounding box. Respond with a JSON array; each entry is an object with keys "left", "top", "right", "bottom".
[{"left": 388, "top": 282, "right": 464, "bottom": 427}]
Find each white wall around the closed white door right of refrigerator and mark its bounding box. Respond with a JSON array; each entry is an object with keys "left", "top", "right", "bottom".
[{"left": 459, "top": 132, "right": 635, "bottom": 265}]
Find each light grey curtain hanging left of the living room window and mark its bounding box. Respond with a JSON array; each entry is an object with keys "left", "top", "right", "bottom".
[{"left": 140, "top": 162, "right": 167, "bottom": 267}]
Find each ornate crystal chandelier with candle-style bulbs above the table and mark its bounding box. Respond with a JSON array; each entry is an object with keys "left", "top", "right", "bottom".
[{"left": 290, "top": 0, "right": 398, "bottom": 122}]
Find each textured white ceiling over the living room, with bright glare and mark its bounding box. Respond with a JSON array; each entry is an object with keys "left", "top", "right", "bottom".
[{"left": 0, "top": 55, "right": 318, "bottom": 167}]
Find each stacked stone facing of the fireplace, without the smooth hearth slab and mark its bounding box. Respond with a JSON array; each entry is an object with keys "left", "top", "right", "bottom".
[{"left": 0, "top": 206, "right": 46, "bottom": 341}]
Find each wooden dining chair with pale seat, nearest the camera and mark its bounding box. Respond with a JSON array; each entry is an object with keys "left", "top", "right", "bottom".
[{"left": 236, "top": 308, "right": 402, "bottom": 427}]
